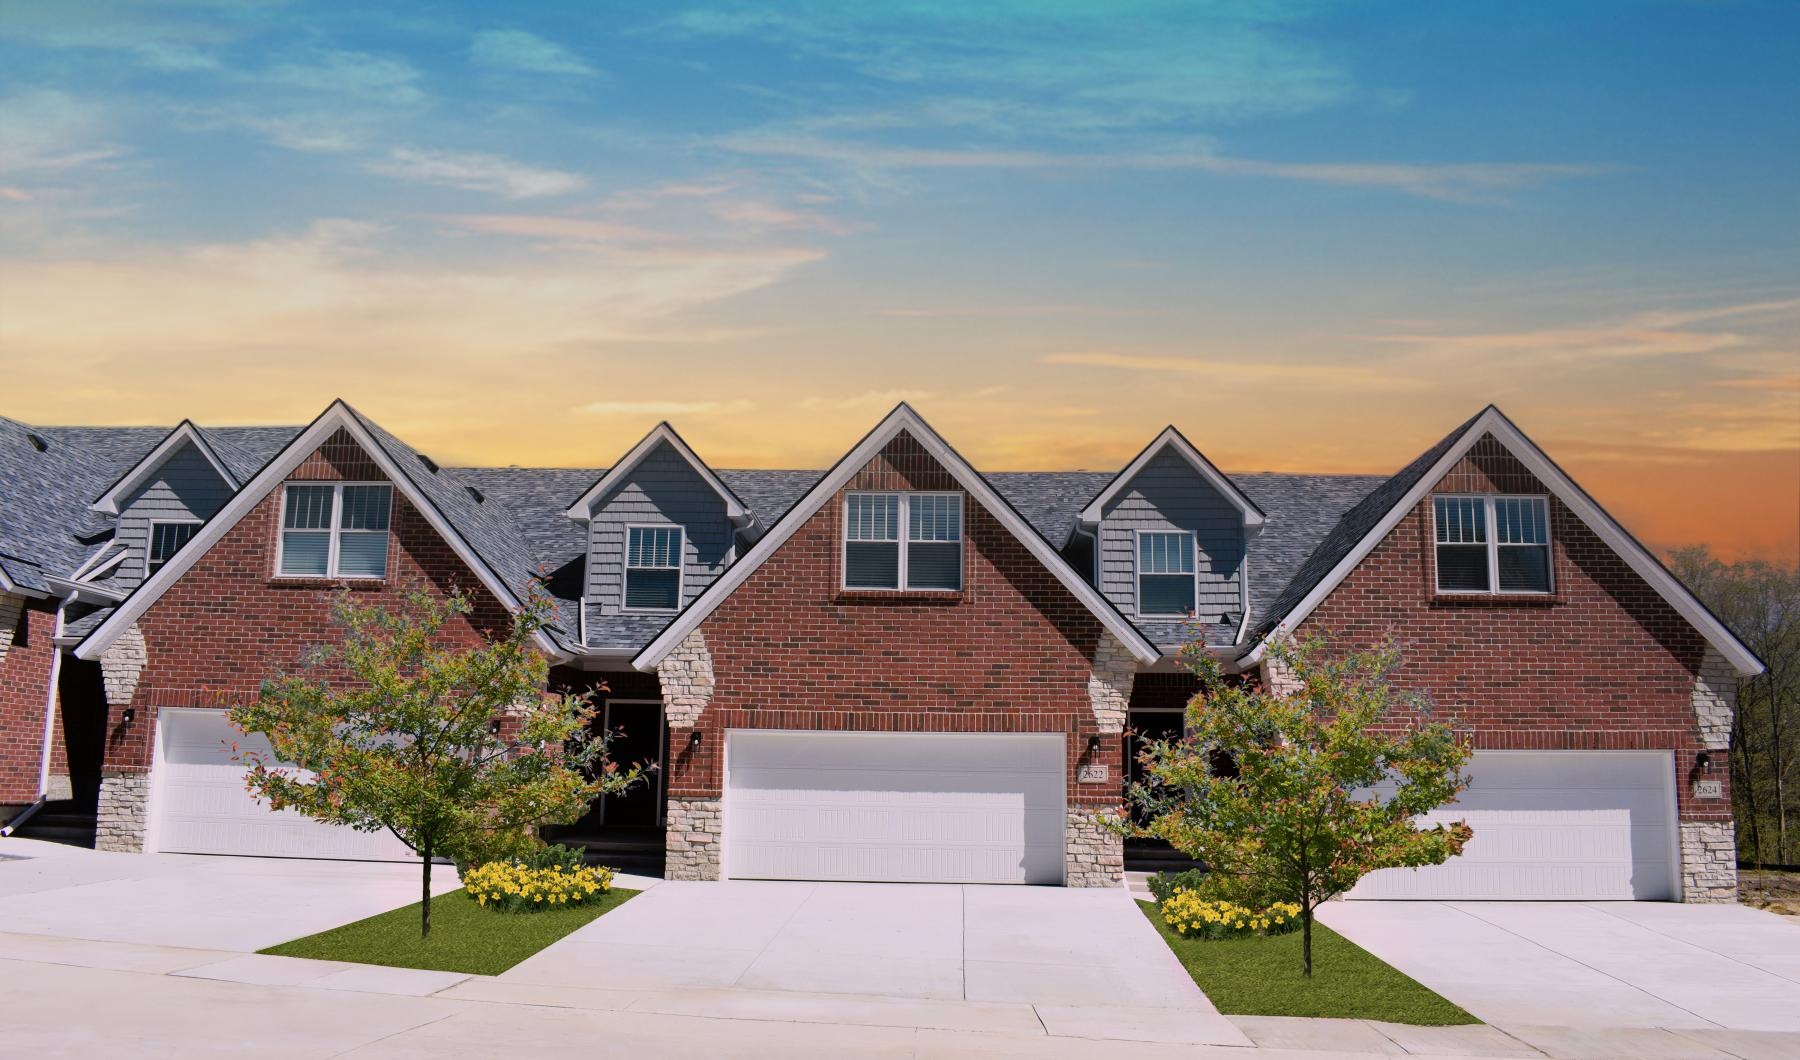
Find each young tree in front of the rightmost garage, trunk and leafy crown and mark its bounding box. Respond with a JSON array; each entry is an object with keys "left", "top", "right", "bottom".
[{"left": 1130, "top": 642, "right": 1472, "bottom": 975}]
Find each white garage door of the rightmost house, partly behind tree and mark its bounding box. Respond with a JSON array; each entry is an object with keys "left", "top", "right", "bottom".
[{"left": 1348, "top": 750, "right": 1676, "bottom": 902}]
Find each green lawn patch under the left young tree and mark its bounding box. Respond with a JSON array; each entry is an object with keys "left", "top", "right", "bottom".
[{"left": 263, "top": 887, "right": 637, "bottom": 975}]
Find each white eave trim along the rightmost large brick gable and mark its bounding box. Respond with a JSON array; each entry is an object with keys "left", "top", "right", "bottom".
[{"left": 1244, "top": 405, "right": 1766, "bottom": 677}]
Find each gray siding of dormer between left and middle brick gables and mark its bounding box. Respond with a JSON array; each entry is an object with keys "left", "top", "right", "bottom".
[{"left": 587, "top": 443, "right": 736, "bottom": 615}]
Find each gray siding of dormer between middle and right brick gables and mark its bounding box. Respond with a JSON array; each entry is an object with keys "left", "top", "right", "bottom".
[{"left": 1100, "top": 448, "right": 1244, "bottom": 624}]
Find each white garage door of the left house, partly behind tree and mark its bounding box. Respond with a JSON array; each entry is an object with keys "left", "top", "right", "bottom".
[{"left": 149, "top": 711, "right": 414, "bottom": 860}]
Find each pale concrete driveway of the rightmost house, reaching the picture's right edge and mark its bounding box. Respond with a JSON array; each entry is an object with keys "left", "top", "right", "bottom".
[{"left": 1319, "top": 902, "right": 1800, "bottom": 1031}]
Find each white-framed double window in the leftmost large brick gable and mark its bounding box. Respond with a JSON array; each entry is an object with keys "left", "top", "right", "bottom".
[{"left": 275, "top": 482, "right": 394, "bottom": 578}]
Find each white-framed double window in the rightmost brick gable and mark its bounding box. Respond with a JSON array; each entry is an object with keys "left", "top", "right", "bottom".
[{"left": 1431, "top": 497, "right": 1552, "bottom": 592}]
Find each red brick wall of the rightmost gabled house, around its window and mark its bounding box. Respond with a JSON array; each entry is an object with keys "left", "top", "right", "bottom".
[{"left": 1300, "top": 437, "right": 1730, "bottom": 819}]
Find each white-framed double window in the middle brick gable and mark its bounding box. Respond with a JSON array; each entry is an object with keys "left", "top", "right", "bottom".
[{"left": 844, "top": 493, "right": 963, "bottom": 592}]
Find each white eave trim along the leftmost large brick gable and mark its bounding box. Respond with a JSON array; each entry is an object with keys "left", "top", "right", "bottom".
[{"left": 76, "top": 400, "right": 569, "bottom": 660}]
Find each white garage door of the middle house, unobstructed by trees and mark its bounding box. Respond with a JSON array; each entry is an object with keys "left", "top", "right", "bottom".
[{"left": 724, "top": 729, "right": 1066, "bottom": 884}]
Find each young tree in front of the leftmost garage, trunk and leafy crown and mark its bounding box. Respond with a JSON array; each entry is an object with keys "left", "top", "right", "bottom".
[{"left": 230, "top": 585, "right": 641, "bottom": 936}]
